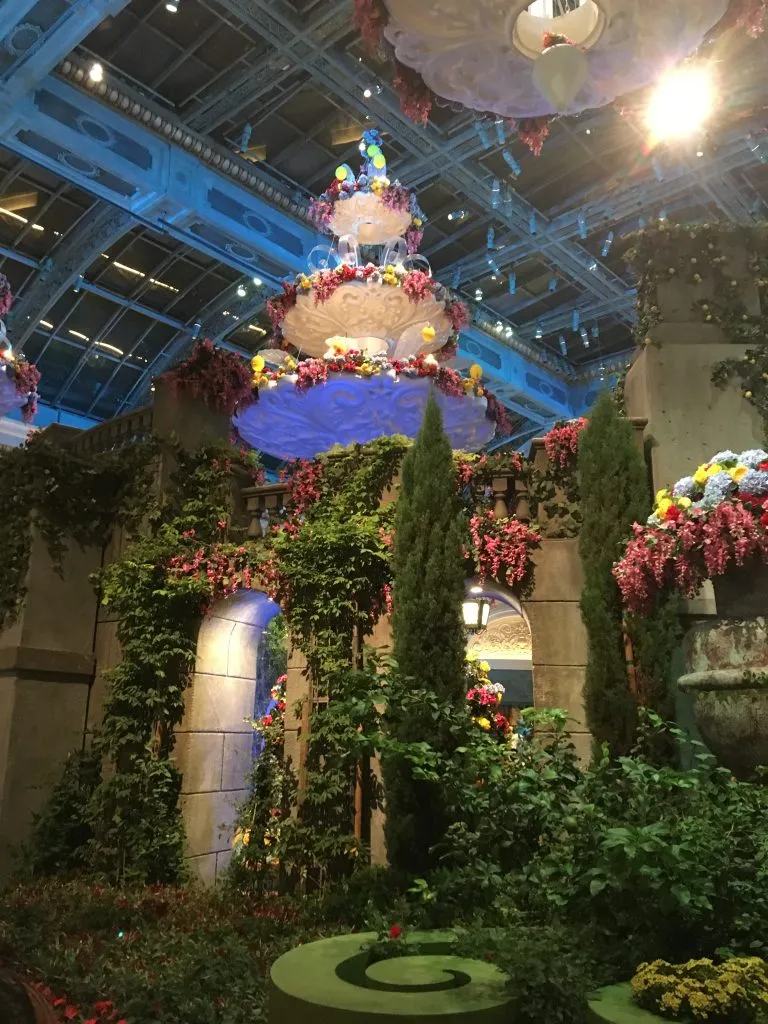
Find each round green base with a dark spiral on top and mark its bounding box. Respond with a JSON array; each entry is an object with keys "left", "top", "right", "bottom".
[{"left": 269, "top": 933, "right": 509, "bottom": 1024}]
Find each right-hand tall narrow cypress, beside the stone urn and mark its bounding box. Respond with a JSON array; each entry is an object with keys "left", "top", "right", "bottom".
[{"left": 579, "top": 391, "right": 650, "bottom": 756}]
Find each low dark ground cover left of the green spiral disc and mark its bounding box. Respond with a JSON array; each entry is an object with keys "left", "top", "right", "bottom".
[{"left": 0, "top": 881, "right": 324, "bottom": 1024}]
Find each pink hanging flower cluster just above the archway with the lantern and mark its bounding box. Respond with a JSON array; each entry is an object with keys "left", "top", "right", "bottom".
[{"left": 469, "top": 510, "right": 540, "bottom": 595}]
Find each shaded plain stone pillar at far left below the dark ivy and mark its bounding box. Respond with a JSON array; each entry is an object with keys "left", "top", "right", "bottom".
[{"left": 0, "top": 529, "right": 101, "bottom": 878}]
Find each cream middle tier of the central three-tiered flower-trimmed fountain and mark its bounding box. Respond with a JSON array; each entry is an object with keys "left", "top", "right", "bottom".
[{"left": 282, "top": 281, "right": 453, "bottom": 358}]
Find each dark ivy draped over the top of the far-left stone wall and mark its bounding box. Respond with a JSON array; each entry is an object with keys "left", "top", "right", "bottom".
[{"left": 0, "top": 432, "right": 156, "bottom": 629}]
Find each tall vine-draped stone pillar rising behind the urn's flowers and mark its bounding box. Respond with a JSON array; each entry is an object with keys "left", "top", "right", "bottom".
[{"left": 626, "top": 243, "right": 764, "bottom": 490}]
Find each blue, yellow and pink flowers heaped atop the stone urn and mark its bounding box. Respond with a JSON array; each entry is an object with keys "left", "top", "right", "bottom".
[{"left": 613, "top": 449, "right": 768, "bottom": 611}]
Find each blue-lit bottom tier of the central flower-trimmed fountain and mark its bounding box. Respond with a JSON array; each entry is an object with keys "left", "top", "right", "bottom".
[{"left": 232, "top": 374, "right": 496, "bottom": 459}]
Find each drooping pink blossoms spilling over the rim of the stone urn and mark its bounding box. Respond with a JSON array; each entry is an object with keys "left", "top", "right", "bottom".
[{"left": 613, "top": 499, "right": 768, "bottom": 612}]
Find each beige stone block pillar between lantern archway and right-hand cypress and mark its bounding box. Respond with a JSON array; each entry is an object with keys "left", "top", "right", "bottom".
[{"left": 523, "top": 538, "right": 592, "bottom": 762}]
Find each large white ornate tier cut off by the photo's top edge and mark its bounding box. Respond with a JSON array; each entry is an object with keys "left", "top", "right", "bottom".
[{"left": 385, "top": 0, "right": 728, "bottom": 119}]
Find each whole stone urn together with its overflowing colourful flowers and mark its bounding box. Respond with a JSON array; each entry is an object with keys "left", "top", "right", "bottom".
[{"left": 613, "top": 449, "right": 768, "bottom": 777}]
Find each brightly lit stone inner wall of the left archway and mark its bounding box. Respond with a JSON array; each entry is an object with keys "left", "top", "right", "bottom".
[{"left": 175, "top": 590, "right": 280, "bottom": 883}]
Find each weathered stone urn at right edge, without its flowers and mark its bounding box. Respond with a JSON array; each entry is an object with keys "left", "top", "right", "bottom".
[{"left": 678, "top": 561, "right": 768, "bottom": 779}]
